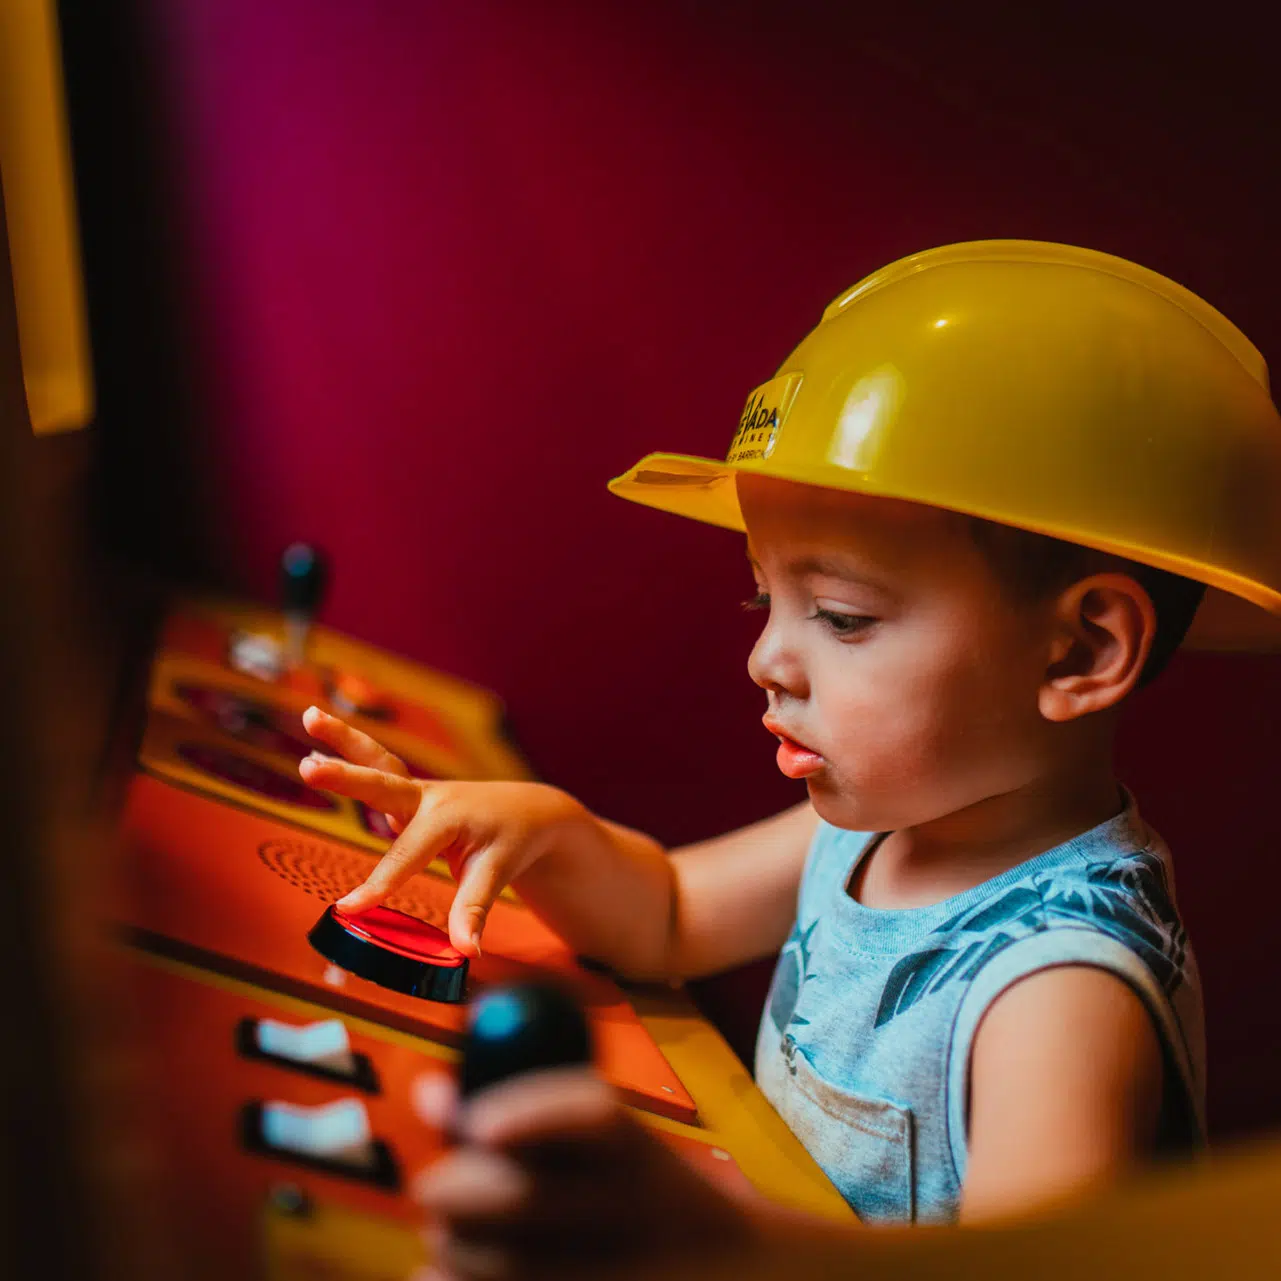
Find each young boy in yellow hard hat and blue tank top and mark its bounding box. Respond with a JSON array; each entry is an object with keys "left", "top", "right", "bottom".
[{"left": 301, "top": 241, "right": 1281, "bottom": 1275}]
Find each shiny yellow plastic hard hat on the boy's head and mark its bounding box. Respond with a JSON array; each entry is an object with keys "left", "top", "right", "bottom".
[{"left": 610, "top": 241, "right": 1281, "bottom": 648}]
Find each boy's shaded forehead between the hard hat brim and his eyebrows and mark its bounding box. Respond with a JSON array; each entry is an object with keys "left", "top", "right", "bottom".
[{"left": 738, "top": 475, "right": 968, "bottom": 561}]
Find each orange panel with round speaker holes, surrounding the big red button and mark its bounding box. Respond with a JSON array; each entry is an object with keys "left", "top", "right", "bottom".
[{"left": 122, "top": 775, "right": 696, "bottom": 1121}]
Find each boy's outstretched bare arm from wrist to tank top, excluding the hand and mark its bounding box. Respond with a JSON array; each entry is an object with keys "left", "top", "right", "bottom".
[{"left": 514, "top": 802, "right": 819, "bottom": 979}]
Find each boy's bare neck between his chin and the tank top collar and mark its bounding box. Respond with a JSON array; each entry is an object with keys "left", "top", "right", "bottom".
[{"left": 848, "top": 757, "right": 1123, "bottom": 910}]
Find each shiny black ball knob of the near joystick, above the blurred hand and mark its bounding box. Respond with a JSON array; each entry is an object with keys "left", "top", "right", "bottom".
[{"left": 459, "top": 983, "right": 592, "bottom": 1098}]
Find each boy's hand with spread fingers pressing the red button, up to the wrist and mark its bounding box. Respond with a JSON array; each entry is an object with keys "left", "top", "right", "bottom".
[{"left": 298, "top": 707, "right": 587, "bottom": 957}]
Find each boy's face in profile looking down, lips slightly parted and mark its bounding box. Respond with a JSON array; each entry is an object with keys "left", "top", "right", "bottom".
[{"left": 738, "top": 475, "right": 1050, "bottom": 831}]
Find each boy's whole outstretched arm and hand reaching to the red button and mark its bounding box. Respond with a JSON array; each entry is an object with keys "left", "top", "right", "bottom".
[{"left": 298, "top": 707, "right": 819, "bottom": 980}]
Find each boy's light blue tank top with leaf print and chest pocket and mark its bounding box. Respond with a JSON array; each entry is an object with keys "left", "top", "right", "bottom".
[{"left": 756, "top": 797, "right": 1204, "bottom": 1223}]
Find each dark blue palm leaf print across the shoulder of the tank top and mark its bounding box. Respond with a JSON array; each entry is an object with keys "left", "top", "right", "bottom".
[{"left": 876, "top": 852, "right": 1187, "bottom": 1027}]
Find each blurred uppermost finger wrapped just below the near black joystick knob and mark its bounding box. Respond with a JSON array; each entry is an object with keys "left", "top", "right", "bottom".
[{"left": 461, "top": 1067, "right": 624, "bottom": 1148}]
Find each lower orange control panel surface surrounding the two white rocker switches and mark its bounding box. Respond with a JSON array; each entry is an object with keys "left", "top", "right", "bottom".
[{"left": 123, "top": 957, "right": 748, "bottom": 1277}]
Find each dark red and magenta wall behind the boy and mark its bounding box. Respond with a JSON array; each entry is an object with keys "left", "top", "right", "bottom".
[{"left": 107, "top": 0, "right": 1281, "bottom": 1134}]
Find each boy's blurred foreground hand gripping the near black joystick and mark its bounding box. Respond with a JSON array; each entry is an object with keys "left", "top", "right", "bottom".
[{"left": 414, "top": 1068, "right": 753, "bottom": 1281}]
